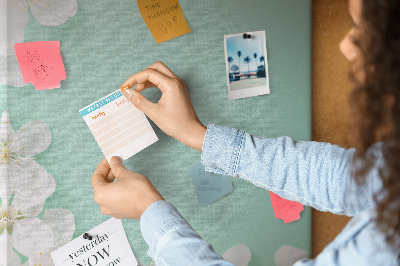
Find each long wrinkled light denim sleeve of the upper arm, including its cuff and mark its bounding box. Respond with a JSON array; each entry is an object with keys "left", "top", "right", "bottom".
[{"left": 202, "top": 124, "right": 381, "bottom": 216}]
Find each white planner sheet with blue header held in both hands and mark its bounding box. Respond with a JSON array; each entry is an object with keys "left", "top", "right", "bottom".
[{"left": 79, "top": 90, "right": 158, "bottom": 161}]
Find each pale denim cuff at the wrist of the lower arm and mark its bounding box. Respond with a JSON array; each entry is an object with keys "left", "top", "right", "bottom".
[{"left": 140, "top": 200, "right": 190, "bottom": 260}]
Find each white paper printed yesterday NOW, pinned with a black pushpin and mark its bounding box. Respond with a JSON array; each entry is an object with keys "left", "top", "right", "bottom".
[{"left": 51, "top": 218, "right": 138, "bottom": 266}]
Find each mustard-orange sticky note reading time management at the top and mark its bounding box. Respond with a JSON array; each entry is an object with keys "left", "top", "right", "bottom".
[{"left": 137, "top": 0, "right": 190, "bottom": 43}]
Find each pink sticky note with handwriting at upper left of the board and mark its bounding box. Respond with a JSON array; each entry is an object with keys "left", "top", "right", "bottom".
[{"left": 14, "top": 41, "right": 67, "bottom": 90}]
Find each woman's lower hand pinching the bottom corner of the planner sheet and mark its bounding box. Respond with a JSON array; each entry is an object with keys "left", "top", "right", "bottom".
[{"left": 92, "top": 157, "right": 164, "bottom": 219}]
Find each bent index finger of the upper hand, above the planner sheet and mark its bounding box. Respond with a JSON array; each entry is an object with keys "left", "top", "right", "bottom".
[{"left": 121, "top": 68, "right": 172, "bottom": 92}]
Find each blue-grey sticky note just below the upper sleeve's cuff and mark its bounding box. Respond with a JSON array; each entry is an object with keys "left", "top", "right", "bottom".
[{"left": 190, "top": 162, "right": 233, "bottom": 207}]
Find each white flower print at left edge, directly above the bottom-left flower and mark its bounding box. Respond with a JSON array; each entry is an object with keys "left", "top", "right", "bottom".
[{"left": 0, "top": 111, "right": 54, "bottom": 202}]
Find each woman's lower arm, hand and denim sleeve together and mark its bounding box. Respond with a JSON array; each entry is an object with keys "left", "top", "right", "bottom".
[{"left": 92, "top": 157, "right": 233, "bottom": 266}]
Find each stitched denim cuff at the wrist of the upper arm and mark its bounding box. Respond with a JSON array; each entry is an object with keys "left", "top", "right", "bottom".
[{"left": 201, "top": 124, "right": 245, "bottom": 177}]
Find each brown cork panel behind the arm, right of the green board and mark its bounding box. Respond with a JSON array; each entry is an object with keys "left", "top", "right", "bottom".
[{"left": 312, "top": 0, "right": 353, "bottom": 257}]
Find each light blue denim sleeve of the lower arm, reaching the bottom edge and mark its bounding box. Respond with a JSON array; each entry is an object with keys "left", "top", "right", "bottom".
[{"left": 140, "top": 200, "right": 234, "bottom": 266}]
